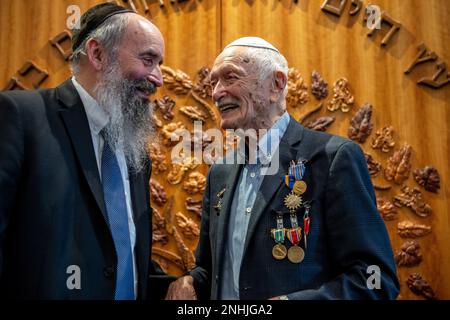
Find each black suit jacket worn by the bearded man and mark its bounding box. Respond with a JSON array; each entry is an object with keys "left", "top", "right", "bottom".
[{"left": 0, "top": 80, "right": 174, "bottom": 299}]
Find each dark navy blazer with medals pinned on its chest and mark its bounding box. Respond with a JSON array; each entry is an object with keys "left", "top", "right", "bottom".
[{"left": 191, "top": 118, "right": 399, "bottom": 299}]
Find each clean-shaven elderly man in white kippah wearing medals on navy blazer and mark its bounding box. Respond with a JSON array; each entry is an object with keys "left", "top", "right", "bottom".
[{"left": 167, "top": 37, "right": 399, "bottom": 299}]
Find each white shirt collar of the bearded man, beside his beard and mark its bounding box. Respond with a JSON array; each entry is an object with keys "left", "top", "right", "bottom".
[{"left": 71, "top": 77, "right": 109, "bottom": 135}]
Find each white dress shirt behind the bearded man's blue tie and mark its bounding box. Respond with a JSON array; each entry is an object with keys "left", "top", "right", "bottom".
[{"left": 72, "top": 77, "right": 138, "bottom": 298}]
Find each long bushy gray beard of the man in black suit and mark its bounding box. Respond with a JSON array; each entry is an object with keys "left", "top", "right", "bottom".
[{"left": 94, "top": 63, "right": 156, "bottom": 172}]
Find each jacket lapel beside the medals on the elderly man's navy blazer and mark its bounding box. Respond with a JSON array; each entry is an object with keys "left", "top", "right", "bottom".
[{"left": 243, "top": 117, "right": 303, "bottom": 257}]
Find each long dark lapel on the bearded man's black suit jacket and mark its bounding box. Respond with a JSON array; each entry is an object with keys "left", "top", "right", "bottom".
[{"left": 56, "top": 80, "right": 108, "bottom": 221}]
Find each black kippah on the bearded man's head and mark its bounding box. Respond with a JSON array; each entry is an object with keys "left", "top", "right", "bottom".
[{"left": 72, "top": 2, "right": 134, "bottom": 51}]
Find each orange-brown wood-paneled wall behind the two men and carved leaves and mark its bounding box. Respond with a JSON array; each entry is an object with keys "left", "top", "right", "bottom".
[{"left": 0, "top": 0, "right": 450, "bottom": 299}]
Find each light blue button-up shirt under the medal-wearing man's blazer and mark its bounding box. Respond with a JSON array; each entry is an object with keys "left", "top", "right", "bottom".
[{"left": 219, "top": 112, "right": 290, "bottom": 300}]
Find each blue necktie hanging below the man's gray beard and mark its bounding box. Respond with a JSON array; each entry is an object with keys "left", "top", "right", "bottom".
[{"left": 102, "top": 137, "right": 135, "bottom": 300}]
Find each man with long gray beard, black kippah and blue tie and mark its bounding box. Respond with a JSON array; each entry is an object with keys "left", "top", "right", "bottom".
[{"left": 0, "top": 3, "right": 174, "bottom": 300}]
